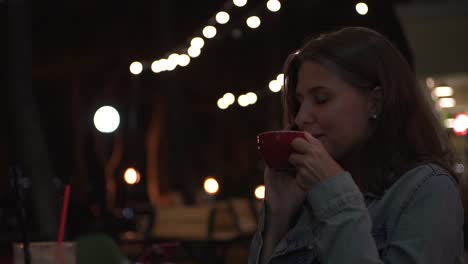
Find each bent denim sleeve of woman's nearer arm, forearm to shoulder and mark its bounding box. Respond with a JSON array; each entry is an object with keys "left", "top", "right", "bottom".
[{"left": 307, "top": 170, "right": 463, "bottom": 264}]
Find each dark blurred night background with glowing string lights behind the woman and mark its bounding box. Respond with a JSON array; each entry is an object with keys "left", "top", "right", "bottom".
[{"left": 0, "top": 0, "right": 468, "bottom": 263}]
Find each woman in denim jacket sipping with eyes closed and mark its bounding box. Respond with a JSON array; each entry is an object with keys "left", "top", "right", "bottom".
[{"left": 249, "top": 27, "right": 463, "bottom": 264}]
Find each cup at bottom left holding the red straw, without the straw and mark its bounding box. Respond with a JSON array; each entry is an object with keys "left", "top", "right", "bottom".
[{"left": 13, "top": 241, "right": 76, "bottom": 264}]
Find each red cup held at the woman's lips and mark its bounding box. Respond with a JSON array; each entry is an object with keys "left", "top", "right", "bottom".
[{"left": 257, "top": 130, "right": 305, "bottom": 170}]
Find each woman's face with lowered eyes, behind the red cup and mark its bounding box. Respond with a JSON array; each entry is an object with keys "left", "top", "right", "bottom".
[{"left": 295, "top": 62, "right": 374, "bottom": 161}]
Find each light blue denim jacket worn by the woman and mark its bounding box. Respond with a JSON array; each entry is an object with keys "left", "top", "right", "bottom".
[{"left": 249, "top": 164, "right": 464, "bottom": 264}]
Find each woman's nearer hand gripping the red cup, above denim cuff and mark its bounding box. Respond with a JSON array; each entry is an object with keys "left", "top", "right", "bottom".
[{"left": 289, "top": 132, "right": 344, "bottom": 192}]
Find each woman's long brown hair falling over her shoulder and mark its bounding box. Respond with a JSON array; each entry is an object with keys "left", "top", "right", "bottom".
[{"left": 283, "top": 27, "right": 458, "bottom": 193}]
